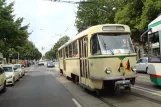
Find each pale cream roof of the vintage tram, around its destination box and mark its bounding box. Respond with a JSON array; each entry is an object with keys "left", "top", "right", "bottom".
[{"left": 58, "top": 24, "right": 130, "bottom": 50}]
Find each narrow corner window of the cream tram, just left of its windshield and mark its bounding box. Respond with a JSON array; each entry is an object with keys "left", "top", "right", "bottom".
[{"left": 91, "top": 35, "right": 101, "bottom": 55}]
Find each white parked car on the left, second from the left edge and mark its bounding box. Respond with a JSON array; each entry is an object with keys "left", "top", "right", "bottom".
[{"left": 3, "top": 65, "right": 20, "bottom": 85}]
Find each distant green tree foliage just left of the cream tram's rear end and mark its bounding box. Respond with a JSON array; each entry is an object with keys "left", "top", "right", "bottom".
[{"left": 45, "top": 36, "right": 69, "bottom": 59}]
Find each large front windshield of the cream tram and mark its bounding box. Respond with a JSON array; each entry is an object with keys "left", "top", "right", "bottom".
[{"left": 94, "top": 34, "right": 134, "bottom": 55}]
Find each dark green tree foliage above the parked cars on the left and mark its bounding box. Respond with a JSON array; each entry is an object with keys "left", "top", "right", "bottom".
[{"left": 0, "top": 0, "right": 41, "bottom": 59}]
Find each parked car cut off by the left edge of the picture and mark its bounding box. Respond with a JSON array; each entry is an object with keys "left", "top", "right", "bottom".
[{"left": 0, "top": 66, "right": 6, "bottom": 92}]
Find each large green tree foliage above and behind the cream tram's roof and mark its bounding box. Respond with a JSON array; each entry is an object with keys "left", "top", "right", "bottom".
[{"left": 76, "top": 0, "right": 161, "bottom": 41}]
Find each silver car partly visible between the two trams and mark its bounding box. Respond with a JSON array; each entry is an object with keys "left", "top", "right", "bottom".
[{"left": 136, "top": 57, "right": 148, "bottom": 73}]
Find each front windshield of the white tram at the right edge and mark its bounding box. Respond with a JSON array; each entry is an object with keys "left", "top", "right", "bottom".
[{"left": 148, "top": 32, "right": 161, "bottom": 63}]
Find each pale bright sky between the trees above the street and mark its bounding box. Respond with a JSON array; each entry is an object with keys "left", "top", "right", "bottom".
[{"left": 7, "top": 0, "right": 80, "bottom": 54}]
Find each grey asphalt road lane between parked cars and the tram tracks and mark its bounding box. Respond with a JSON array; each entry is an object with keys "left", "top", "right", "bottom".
[{"left": 0, "top": 66, "right": 77, "bottom": 107}]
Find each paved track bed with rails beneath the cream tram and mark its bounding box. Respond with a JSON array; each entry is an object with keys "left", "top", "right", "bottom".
[{"left": 22, "top": 66, "right": 161, "bottom": 107}]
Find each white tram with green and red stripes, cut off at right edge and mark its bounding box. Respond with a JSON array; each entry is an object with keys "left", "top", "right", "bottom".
[{"left": 142, "top": 15, "right": 161, "bottom": 86}]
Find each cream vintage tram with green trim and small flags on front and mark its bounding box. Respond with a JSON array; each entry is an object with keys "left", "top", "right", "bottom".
[{"left": 58, "top": 24, "right": 137, "bottom": 92}]
